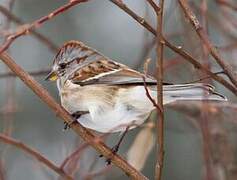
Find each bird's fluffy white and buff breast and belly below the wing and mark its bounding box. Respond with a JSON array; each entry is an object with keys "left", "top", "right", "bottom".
[{"left": 60, "top": 82, "right": 154, "bottom": 133}]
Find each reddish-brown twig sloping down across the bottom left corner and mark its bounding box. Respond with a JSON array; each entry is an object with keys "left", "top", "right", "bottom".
[{"left": 0, "top": 134, "right": 73, "bottom": 180}]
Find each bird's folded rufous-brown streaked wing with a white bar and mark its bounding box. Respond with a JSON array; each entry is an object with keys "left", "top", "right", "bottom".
[{"left": 70, "top": 60, "right": 164, "bottom": 85}]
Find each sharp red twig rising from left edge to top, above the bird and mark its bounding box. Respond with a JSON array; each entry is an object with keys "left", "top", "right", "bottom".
[{"left": 0, "top": 0, "right": 88, "bottom": 54}]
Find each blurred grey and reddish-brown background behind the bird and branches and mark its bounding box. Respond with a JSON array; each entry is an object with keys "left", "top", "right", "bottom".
[{"left": 0, "top": 0, "right": 237, "bottom": 180}]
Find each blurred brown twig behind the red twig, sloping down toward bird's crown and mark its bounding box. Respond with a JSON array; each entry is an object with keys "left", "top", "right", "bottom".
[{"left": 0, "top": 6, "right": 59, "bottom": 52}]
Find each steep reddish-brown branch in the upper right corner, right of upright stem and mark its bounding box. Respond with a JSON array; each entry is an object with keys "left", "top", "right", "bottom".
[{"left": 179, "top": 0, "right": 237, "bottom": 87}]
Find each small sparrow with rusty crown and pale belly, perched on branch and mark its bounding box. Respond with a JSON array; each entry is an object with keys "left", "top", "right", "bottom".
[{"left": 46, "top": 40, "right": 227, "bottom": 133}]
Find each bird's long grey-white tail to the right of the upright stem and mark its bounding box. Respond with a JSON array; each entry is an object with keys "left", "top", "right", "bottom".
[{"left": 163, "top": 83, "right": 227, "bottom": 103}]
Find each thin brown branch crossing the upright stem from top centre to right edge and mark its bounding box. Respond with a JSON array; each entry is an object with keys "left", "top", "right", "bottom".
[{"left": 109, "top": 0, "right": 237, "bottom": 95}]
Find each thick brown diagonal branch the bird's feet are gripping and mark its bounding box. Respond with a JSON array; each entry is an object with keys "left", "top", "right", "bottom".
[{"left": 0, "top": 53, "right": 147, "bottom": 179}]
